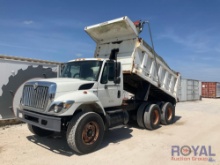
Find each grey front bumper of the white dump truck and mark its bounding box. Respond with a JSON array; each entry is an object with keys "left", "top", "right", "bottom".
[{"left": 17, "top": 110, "right": 61, "bottom": 132}]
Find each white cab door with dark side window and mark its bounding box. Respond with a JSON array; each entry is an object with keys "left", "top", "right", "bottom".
[{"left": 98, "top": 60, "right": 123, "bottom": 108}]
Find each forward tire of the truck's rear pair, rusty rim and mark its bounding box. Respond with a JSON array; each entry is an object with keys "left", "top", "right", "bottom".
[{"left": 144, "top": 104, "right": 161, "bottom": 130}]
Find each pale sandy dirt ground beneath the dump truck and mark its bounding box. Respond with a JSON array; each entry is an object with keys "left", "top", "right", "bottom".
[{"left": 0, "top": 99, "right": 220, "bottom": 165}]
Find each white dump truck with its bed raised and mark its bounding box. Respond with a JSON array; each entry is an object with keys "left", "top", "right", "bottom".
[{"left": 17, "top": 16, "right": 180, "bottom": 154}]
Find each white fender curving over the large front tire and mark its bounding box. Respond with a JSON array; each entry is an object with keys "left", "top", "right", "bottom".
[{"left": 49, "top": 90, "right": 106, "bottom": 116}]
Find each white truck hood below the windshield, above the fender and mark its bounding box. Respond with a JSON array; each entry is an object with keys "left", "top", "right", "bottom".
[{"left": 35, "top": 78, "right": 95, "bottom": 93}]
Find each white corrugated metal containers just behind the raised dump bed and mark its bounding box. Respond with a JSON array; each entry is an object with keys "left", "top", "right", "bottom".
[{"left": 178, "top": 78, "right": 201, "bottom": 101}]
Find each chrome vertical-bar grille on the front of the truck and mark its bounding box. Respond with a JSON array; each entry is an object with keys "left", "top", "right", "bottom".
[{"left": 22, "top": 85, "right": 49, "bottom": 110}]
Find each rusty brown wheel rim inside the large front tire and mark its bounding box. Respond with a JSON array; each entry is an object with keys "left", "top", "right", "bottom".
[{"left": 82, "top": 121, "right": 99, "bottom": 145}]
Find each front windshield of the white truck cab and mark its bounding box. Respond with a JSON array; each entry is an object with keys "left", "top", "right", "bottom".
[{"left": 61, "top": 60, "right": 102, "bottom": 81}]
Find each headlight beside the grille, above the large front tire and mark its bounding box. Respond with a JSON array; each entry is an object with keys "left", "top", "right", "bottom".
[{"left": 49, "top": 100, "right": 74, "bottom": 113}]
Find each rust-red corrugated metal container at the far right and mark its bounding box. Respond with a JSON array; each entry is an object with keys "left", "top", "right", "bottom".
[{"left": 202, "top": 82, "right": 220, "bottom": 98}]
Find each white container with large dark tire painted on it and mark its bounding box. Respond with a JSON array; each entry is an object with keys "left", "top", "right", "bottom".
[{"left": 0, "top": 55, "right": 60, "bottom": 120}]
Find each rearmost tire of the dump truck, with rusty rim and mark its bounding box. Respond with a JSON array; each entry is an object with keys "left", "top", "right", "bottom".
[{"left": 161, "top": 102, "right": 175, "bottom": 125}]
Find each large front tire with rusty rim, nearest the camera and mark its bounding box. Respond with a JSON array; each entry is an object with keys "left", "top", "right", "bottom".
[{"left": 66, "top": 112, "right": 105, "bottom": 154}]
